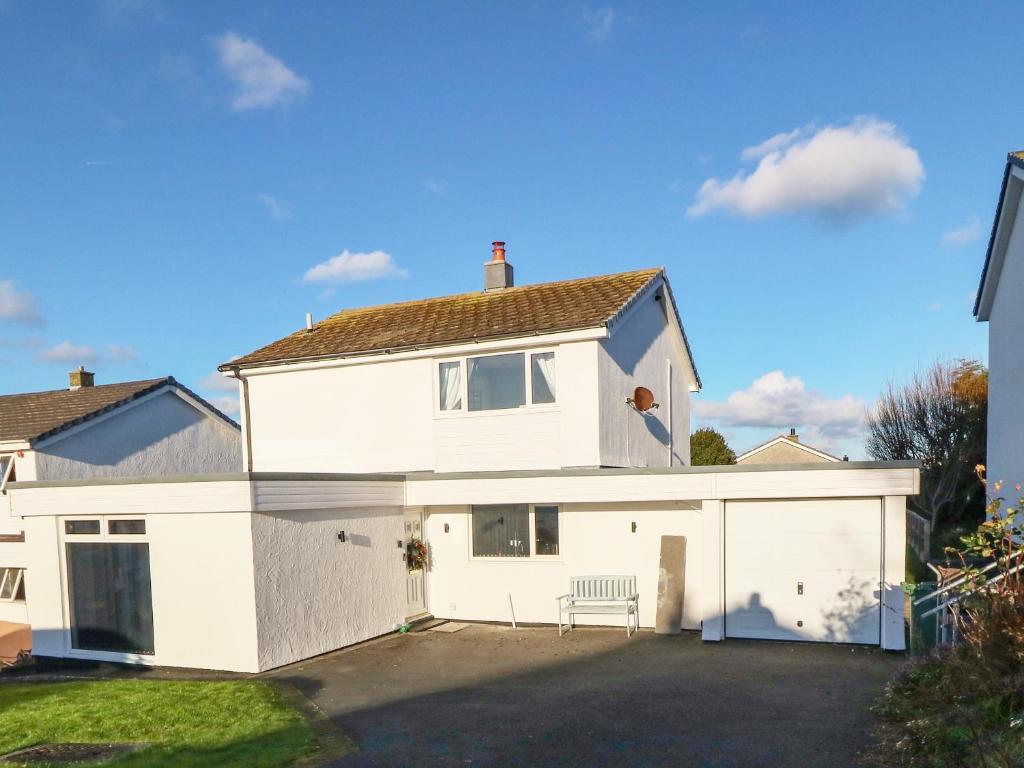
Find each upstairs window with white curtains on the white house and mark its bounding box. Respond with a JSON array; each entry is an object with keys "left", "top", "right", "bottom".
[{"left": 436, "top": 351, "right": 556, "bottom": 413}]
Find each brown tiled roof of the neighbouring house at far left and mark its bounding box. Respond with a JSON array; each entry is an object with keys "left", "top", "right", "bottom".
[{"left": 0, "top": 376, "right": 238, "bottom": 442}]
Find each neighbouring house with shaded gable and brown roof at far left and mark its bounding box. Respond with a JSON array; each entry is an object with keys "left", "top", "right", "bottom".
[{"left": 0, "top": 369, "right": 242, "bottom": 624}]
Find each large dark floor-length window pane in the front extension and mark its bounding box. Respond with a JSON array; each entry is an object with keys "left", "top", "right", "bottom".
[{"left": 65, "top": 542, "right": 154, "bottom": 653}]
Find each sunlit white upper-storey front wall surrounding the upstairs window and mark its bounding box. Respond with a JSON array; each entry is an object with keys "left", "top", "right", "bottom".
[{"left": 248, "top": 340, "right": 602, "bottom": 472}]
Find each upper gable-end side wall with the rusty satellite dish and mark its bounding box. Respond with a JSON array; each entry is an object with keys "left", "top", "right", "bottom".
[{"left": 598, "top": 294, "right": 690, "bottom": 467}]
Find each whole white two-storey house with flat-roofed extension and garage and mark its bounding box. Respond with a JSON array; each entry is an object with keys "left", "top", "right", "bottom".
[{"left": 9, "top": 243, "right": 919, "bottom": 672}]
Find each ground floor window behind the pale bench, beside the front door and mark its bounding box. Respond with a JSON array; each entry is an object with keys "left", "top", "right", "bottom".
[{"left": 471, "top": 504, "right": 558, "bottom": 557}]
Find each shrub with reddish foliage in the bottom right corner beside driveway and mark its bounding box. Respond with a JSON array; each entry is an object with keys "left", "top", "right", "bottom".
[{"left": 865, "top": 484, "right": 1024, "bottom": 768}]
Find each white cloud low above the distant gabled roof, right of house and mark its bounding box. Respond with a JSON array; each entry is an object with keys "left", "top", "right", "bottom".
[{"left": 694, "top": 371, "right": 866, "bottom": 438}]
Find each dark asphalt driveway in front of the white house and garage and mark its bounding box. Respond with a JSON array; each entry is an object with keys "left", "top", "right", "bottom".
[{"left": 270, "top": 625, "right": 901, "bottom": 768}]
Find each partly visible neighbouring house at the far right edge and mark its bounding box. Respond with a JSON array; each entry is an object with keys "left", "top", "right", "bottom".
[{"left": 974, "top": 152, "right": 1024, "bottom": 486}]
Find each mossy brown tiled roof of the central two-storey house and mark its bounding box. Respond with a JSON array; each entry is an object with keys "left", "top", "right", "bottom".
[{"left": 220, "top": 269, "right": 663, "bottom": 371}]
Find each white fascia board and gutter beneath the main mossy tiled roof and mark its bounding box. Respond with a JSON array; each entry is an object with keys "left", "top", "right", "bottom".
[{"left": 231, "top": 326, "right": 608, "bottom": 377}]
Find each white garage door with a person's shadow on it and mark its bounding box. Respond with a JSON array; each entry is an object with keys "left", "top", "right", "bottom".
[{"left": 725, "top": 499, "right": 882, "bottom": 644}]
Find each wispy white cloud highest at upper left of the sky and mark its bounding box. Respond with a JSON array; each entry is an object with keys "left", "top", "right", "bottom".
[{"left": 216, "top": 32, "right": 309, "bottom": 112}]
